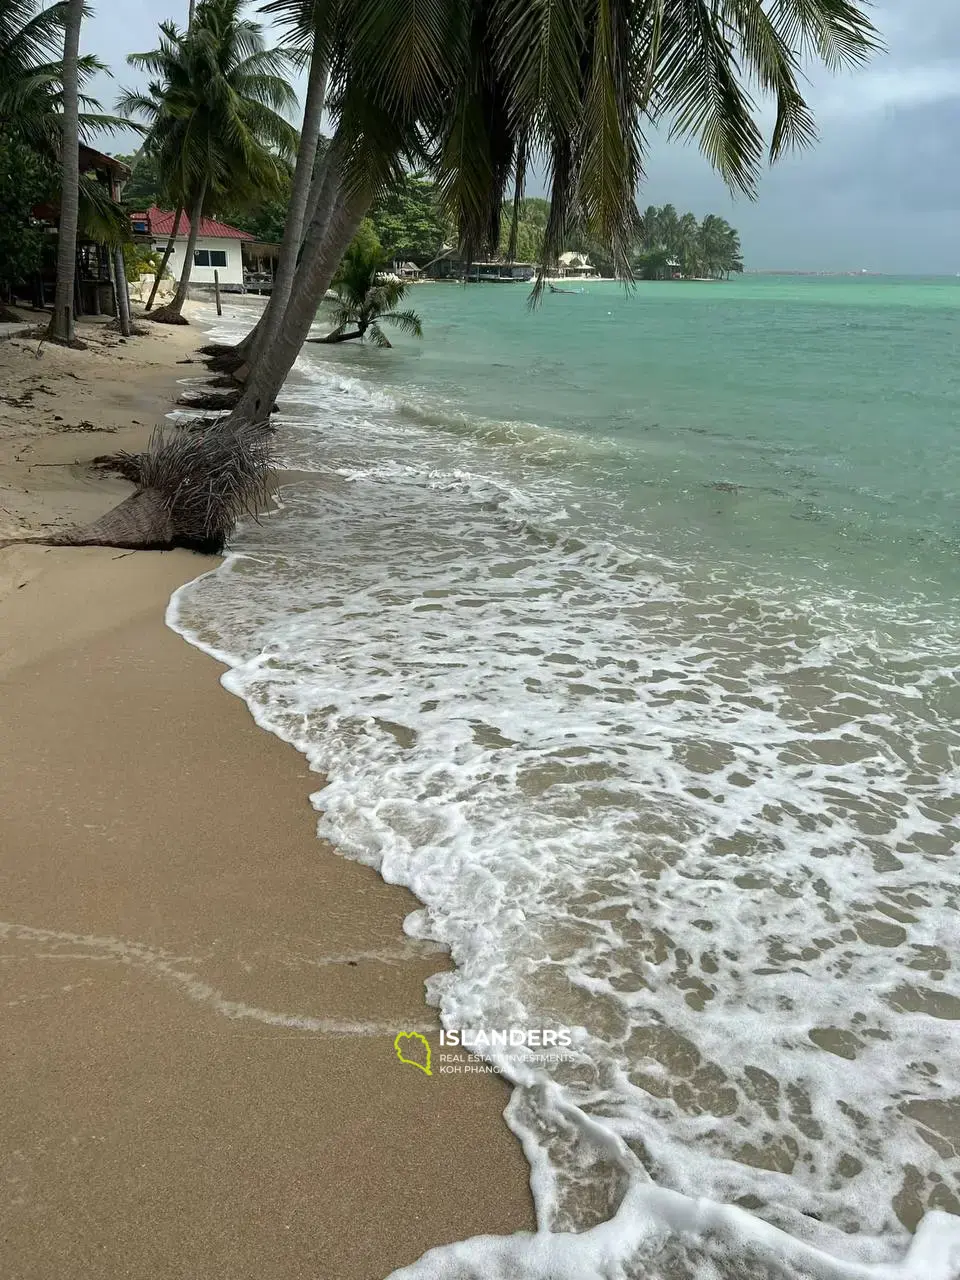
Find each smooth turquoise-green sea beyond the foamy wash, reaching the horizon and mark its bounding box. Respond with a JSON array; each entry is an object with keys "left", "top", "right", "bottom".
[{"left": 325, "top": 276, "right": 960, "bottom": 586}]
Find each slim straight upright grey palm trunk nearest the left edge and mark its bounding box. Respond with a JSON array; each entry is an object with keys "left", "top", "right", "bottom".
[{"left": 49, "top": 0, "right": 83, "bottom": 343}]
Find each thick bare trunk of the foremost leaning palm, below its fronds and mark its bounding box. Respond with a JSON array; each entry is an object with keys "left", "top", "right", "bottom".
[{"left": 227, "top": 179, "right": 372, "bottom": 428}]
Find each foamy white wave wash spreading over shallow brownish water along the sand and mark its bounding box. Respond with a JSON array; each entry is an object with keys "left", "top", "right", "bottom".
[{"left": 169, "top": 325, "right": 960, "bottom": 1280}]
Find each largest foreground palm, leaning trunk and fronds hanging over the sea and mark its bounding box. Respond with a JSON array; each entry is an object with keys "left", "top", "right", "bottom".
[{"left": 224, "top": 0, "right": 878, "bottom": 422}]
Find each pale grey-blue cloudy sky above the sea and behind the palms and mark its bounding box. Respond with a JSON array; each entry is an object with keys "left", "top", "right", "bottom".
[{"left": 82, "top": 0, "right": 960, "bottom": 274}]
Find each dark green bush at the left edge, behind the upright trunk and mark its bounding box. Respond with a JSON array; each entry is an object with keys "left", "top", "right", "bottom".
[{"left": 0, "top": 133, "right": 56, "bottom": 297}]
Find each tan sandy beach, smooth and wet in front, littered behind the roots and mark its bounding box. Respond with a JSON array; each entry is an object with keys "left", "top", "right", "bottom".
[{"left": 0, "top": 312, "right": 534, "bottom": 1280}]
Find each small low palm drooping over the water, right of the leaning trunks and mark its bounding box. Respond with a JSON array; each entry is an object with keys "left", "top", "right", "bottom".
[{"left": 314, "top": 223, "right": 424, "bottom": 347}]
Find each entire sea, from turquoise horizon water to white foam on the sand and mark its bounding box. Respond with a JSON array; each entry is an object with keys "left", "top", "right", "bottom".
[{"left": 172, "top": 278, "right": 960, "bottom": 1280}]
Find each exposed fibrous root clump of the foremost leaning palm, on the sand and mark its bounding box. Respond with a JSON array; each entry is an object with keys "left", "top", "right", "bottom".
[{"left": 0, "top": 422, "right": 274, "bottom": 556}]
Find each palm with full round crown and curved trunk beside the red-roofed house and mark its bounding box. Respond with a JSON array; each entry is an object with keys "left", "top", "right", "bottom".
[{"left": 118, "top": 0, "right": 298, "bottom": 324}]
